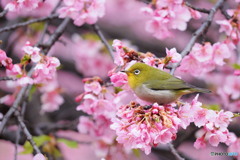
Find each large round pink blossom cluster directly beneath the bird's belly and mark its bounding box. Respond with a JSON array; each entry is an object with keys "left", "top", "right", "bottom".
[{"left": 111, "top": 102, "right": 181, "bottom": 154}]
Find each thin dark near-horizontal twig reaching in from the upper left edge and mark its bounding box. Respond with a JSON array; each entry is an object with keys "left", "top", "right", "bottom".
[{"left": 0, "top": 14, "right": 58, "bottom": 33}]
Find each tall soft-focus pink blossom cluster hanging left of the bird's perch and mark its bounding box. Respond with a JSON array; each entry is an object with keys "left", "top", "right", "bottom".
[{"left": 76, "top": 77, "right": 116, "bottom": 157}]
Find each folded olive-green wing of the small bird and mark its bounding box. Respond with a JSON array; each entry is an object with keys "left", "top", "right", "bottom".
[{"left": 144, "top": 77, "right": 192, "bottom": 90}]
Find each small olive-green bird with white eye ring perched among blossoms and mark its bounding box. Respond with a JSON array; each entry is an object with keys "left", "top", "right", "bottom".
[{"left": 123, "top": 62, "right": 211, "bottom": 105}]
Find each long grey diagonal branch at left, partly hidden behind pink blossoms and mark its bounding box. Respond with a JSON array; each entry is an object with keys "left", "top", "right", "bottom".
[{"left": 0, "top": 18, "right": 70, "bottom": 134}]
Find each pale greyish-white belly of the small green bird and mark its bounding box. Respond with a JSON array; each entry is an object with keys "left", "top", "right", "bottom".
[{"left": 134, "top": 85, "right": 180, "bottom": 104}]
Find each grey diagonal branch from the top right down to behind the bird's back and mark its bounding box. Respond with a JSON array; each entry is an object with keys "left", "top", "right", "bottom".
[{"left": 170, "top": 0, "right": 226, "bottom": 74}]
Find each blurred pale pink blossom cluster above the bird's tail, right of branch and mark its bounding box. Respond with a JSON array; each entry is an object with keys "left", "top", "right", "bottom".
[{"left": 178, "top": 42, "right": 234, "bottom": 77}]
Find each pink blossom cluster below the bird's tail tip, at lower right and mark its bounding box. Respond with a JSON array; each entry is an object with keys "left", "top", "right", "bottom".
[{"left": 179, "top": 98, "right": 236, "bottom": 149}]
